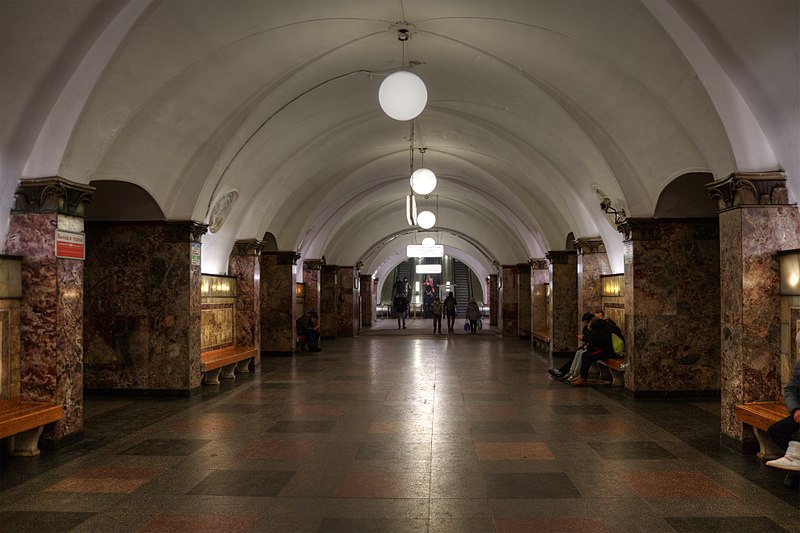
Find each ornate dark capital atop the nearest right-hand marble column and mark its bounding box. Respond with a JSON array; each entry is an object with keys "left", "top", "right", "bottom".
[{"left": 706, "top": 171, "right": 790, "bottom": 213}]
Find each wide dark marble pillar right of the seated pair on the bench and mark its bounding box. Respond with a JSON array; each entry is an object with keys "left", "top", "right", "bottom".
[{"left": 619, "top": 218, "right": 720, "bottom": 396}]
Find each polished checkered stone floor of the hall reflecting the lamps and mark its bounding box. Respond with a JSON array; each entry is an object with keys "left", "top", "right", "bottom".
[{"left": 0, "top": 320, "right": 800, "bottom": 533}]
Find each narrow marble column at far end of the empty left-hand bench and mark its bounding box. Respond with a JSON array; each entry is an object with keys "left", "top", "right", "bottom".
[{"left": 228, "top": 239, "right": 261, "bottom": 371}]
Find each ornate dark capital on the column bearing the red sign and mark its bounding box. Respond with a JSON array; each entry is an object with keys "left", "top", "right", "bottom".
[{"left": 11, "top": 176, "right": 96, "bottom": 217}]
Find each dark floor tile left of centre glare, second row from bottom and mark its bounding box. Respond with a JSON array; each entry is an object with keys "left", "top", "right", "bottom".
[{"left": 187, "top": 470, "right": 294, "bottom": 497}]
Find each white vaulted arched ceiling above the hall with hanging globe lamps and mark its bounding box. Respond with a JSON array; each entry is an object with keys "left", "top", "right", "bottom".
[{"left": 0, "top": 0, "right": 800, "bottom": 272}]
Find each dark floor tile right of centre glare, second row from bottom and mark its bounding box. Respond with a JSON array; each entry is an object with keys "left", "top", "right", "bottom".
[{"left": 484, "top": 472, "right": 581, "bottom": 499}]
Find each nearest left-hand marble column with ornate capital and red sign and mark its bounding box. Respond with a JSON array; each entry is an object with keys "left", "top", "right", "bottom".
[{"left": 6, "top": 177, "right": 94, "bottom": 447}]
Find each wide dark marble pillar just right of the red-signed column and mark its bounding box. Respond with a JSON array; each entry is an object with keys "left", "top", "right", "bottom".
[{"left": 83, "top": 221, "right": 206, "bottom": 395}]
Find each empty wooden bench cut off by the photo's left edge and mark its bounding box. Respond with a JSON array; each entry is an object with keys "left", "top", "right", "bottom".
[{"left": 0, "top": 398, "right": 64, "bottom": 457}]
